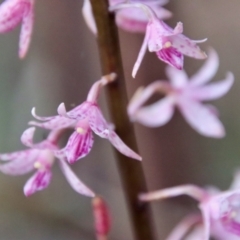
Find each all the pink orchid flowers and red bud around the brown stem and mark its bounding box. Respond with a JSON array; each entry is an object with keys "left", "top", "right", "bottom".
[{"left": 0, "top": 0, "right": 237, "bottom": 240}]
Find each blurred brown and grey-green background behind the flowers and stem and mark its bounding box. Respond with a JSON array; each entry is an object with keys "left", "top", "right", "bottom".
[{"left": 0, "top": 0, "right": 240, "bottom": 240}]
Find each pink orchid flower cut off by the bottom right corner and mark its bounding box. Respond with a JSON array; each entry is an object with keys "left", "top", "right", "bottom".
[{"left": 139, "top": 172, "right": 240, "bottom": 240}]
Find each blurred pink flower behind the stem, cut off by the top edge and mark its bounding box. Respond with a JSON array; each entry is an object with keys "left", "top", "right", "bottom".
[{"left": 82, "top": 0, "right": 172, "bottom": 34}]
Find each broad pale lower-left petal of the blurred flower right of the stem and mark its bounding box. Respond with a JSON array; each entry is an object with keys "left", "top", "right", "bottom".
[{"left": 132, "top": 97, "right": 174, "bottom": 127}]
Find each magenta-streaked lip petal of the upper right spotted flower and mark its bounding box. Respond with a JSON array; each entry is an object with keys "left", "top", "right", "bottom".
[{"left": 156, "top": 47, "right": 183, "bottom": 70}]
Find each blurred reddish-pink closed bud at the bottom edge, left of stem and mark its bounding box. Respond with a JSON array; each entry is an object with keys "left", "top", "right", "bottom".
[{"left": 92, "top": 196, "right": 111, "bottom": 240}]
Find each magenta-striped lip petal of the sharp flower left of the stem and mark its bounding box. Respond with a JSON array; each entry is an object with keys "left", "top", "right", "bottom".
[{"left": 60, "top": 129, "right": 94, "bottom": 164}]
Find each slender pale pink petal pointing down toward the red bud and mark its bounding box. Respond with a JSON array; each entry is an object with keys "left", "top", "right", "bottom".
[{"left": 59, "top": 159, "right": 95, "bottom": 197}]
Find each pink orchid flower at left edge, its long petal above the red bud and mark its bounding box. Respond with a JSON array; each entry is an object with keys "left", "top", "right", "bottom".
[{"left": 0, "top": 127, "right": 95, "bottom": 197}]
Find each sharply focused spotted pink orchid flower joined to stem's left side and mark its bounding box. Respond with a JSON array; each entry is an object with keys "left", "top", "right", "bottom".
[{"left": 30, "top": 74, "right": 141, "bottom": 163}]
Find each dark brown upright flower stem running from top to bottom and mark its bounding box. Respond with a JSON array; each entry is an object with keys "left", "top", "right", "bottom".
[{"left": 91, "top": 0, "right": 154, "bottom": 240}]
